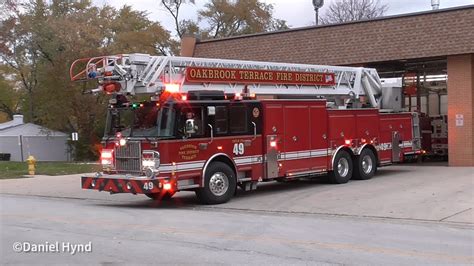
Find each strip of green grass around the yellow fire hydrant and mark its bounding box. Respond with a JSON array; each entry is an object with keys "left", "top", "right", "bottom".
[{"left": 0, "top": 161, "right": 101, "bottom": 179}]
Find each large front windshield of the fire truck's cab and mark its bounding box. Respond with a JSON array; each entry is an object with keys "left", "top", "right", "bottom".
[{"left": 105, "top": 106, "right": 158, "bottom": 137}]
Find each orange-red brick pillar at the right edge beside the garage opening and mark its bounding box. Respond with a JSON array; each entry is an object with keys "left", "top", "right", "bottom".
[{"left": 448, "top": 54, "right": 474, "bottom": 166}]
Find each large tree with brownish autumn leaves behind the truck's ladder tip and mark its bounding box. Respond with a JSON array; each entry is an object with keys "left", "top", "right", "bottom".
[{"left": 0, "top": 0, "right": 177, "bottom": 159}]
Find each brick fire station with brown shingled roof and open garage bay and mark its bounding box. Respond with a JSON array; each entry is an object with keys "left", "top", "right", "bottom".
[{"left": 181, "top": 5, "right": 474, "bottom": 166}]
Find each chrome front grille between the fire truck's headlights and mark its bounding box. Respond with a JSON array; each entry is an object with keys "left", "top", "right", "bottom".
[{"left": 115, "top": 141, "right": 142, "bottom": 174}]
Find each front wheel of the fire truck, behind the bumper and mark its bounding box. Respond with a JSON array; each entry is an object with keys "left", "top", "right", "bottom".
[{"left": 196, "top": 162, "right": 237, "bottom": 204}]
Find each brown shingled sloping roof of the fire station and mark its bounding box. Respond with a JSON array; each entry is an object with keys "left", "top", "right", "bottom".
[{"left": 190, "top": 6, "right": 474, "bottom": 65}]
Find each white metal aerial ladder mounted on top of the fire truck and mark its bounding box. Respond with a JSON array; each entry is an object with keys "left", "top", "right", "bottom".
[{"left": 70, "top": 53, "right": 383, "bottom": 108}]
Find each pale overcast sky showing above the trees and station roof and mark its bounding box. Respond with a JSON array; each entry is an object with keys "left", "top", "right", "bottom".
[{"left": 93, "top": 0, "right": 474, "bottom": 35}]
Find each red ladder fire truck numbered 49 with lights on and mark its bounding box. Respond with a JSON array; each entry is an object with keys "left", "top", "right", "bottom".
[{"left": 70, "top": 54, "right": 420, "bottom": 204}]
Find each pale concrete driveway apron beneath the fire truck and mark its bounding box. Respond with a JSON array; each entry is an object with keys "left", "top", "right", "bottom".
[{"left": 0, "top": 164, "right": 474, "bottom": 224}]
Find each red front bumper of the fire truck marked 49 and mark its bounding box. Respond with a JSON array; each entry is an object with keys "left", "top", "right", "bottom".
[{"left": 81, "top": 176, "right": 170, "bottom": 194}]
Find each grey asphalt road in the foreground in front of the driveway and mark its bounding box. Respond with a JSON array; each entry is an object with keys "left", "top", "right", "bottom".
[{"left": 0, "top": 194, "right": 474, "bottom": 266}]
